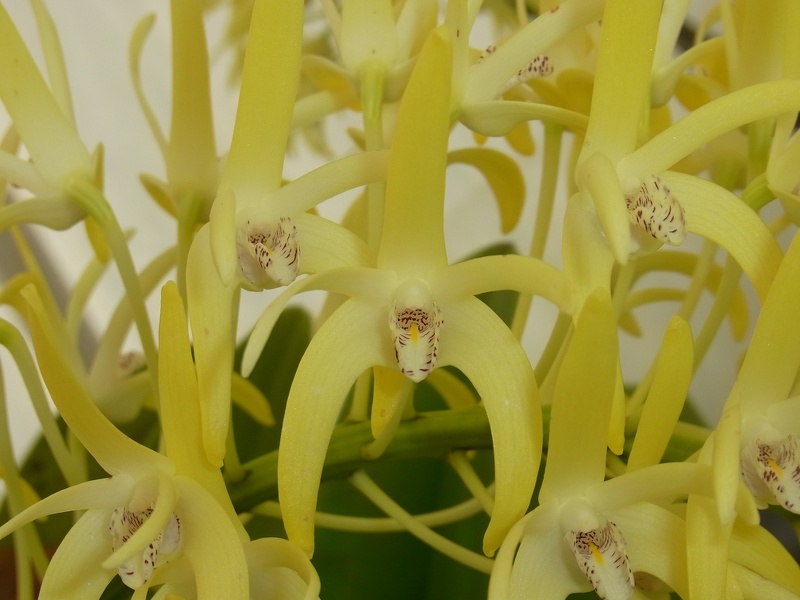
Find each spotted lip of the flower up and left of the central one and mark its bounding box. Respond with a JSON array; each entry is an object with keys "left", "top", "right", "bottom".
[{"left": 237, "top": 217, "right": 300, "bottom": 287}]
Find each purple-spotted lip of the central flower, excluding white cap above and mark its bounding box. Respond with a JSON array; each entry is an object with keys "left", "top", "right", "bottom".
[{"left": 389, "top": 302, "right": 443, "bottom": 382}]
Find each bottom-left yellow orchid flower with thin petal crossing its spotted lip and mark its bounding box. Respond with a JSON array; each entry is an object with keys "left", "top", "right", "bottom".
[{"left": 0, "top": 283, "right": 317, "bottom": 599}]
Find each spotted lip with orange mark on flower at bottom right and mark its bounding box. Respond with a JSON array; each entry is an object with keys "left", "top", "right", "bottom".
[{"left": 565, "top": 521, "right": 635, "bottom": 600}]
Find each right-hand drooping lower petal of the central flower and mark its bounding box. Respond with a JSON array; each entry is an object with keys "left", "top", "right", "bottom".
[{"left": 439, "top": 298, "right": 542, "bottom": 555}]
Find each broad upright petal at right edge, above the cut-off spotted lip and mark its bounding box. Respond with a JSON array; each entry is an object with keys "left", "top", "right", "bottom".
[{"left": 737, "top": 231, "right": 800, "bottom": 418}]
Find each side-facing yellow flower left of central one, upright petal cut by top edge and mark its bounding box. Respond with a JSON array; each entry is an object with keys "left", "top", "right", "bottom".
[{"left": 187, "top": 0, "right": 387, "bottom": 465}]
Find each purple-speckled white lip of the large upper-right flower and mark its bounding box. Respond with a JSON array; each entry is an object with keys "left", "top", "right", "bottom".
[{"left": 625, "top": 175, "right": 686, "bottom": 246}]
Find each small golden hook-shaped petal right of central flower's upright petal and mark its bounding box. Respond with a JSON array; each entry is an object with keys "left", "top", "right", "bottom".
[{"left": 447, "top": 148, "right": 525, "bottom": 233}]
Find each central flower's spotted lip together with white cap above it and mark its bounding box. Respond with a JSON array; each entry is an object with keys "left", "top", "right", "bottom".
[{"left": 389, "top": 280, "right": 443, "bottom": 382}]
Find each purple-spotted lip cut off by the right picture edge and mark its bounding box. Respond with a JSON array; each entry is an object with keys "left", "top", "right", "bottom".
[{"left": 741, "top": 435, "right": 800, "bottom": 514}]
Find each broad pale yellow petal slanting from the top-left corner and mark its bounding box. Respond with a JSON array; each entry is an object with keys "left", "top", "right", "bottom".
[{"left": 0, "top": 2, "right": 93, "bottom": 189}]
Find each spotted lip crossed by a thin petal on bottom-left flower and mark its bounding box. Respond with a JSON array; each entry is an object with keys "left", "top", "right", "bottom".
[{"left": 108, "top": 504, "right": 181, "bottom": 590}]
